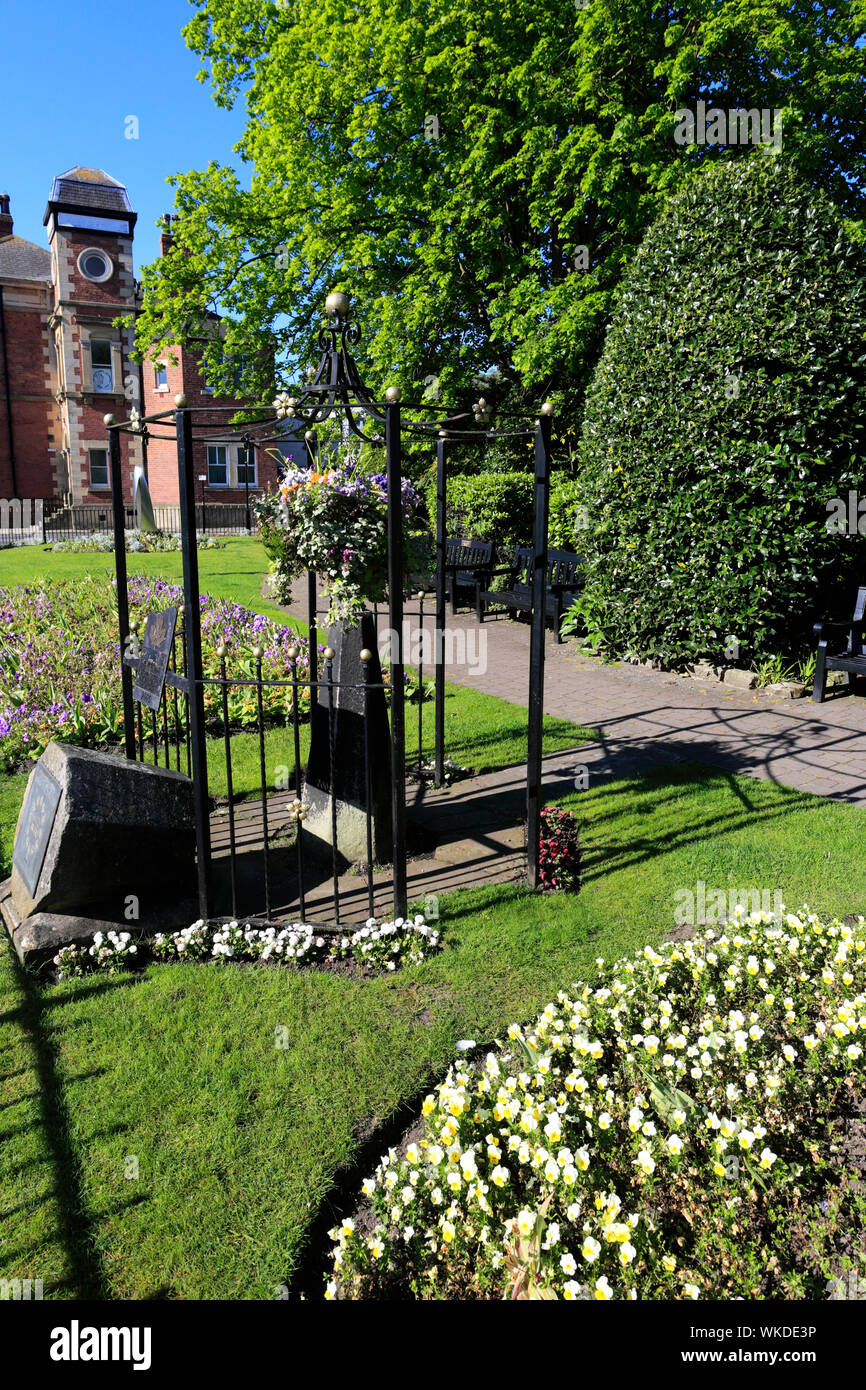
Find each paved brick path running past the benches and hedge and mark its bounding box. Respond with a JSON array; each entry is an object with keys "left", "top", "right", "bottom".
[{"left": 283, "top": 585, "right": 866, "bottom": 805}]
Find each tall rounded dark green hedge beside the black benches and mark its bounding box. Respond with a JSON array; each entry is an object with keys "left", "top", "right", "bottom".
[{"left": 580, "top": 153, "right": 866, "bottom": 664}]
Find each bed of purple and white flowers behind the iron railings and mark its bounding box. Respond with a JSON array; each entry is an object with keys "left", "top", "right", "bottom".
[{"left": 0, "top": 575, "right": 310, "bottom": 770}]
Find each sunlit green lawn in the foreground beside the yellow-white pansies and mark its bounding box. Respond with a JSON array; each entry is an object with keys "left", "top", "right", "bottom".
[{"left": 0, "top": 765, "right": 866, "bottom": 1298}]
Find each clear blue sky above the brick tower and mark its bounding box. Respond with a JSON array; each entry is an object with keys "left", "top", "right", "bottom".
[{"left": 0, "top": 0, "right": 249, "bottom": 268}]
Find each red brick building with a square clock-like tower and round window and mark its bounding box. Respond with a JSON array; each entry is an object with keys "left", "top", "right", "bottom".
[{"left": 0, "top": 165, "right": 300, "bottom": 505}]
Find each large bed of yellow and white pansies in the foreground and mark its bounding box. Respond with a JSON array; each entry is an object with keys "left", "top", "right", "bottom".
[{"left": 325, "top": 909, "right": 866, "bottom": 1300}]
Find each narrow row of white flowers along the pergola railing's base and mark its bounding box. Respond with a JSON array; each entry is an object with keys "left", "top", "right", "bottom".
[{"left": 54, "top": 913, "right": 441, "bottom": 980}]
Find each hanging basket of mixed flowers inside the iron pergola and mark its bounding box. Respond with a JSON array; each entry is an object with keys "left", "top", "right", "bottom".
[{"left": 254, "top": 466, "right": 418, "bottom": 626}]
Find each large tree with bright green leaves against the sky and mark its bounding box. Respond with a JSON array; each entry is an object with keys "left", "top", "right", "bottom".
[{"left": 130, "top": 0, "right": 866, "bottom": 430}]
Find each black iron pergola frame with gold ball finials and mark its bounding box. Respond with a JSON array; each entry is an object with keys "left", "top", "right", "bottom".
[{"left": 104, "top": 292, "right": 553, "bottom": 917}]
